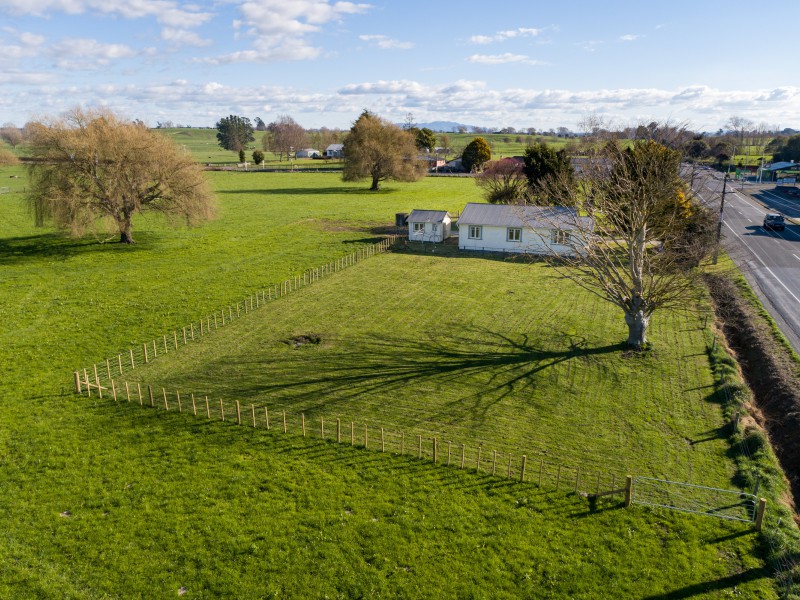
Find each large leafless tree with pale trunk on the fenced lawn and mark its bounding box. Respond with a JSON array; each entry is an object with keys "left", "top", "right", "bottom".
[{"left": 540, "top": 140, "right": 713, "bottom": 349}]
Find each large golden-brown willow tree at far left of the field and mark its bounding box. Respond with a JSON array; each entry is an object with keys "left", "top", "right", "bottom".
[{"left": 28, "top": 109, "right": 213, "bottom": 244}]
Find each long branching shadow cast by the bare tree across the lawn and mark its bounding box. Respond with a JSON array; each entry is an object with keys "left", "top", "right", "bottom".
[{"left": 204, "top": 328, "right": 625, "bottom": 422}]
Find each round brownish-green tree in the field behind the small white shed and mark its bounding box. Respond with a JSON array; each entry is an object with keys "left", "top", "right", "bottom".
[{"left": 342, "top": 110, "right": 426, "bottom": 190}]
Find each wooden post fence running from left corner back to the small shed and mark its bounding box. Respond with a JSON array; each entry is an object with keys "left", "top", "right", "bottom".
[{"left": 75, "top": 235, "right": 400, "bottom": 394}]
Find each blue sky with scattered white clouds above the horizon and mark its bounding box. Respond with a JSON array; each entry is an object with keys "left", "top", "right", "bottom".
[{"left": 0, "top": 0, "right": 800, "bottom": 131}]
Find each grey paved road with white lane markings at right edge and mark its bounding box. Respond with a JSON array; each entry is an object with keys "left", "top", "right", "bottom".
[{"left": 694, "top": 172, "right": 800, "bottom": 352}]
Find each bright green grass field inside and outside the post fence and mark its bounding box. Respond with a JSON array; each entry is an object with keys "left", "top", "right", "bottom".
[{"left": 0, "top": 168, "right": 776, "bottom": 598}]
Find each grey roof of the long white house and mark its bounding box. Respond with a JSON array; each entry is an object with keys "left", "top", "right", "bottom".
[{"left": 458, "top": 202, "right": 592, "bottom": 229}]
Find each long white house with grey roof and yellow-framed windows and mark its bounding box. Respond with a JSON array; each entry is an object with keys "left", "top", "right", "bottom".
[{"left": 458, "top": 202, "right": 592, "bottom": 255}]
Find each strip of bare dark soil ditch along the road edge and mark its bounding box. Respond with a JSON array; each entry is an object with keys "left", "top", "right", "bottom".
[{"left": 705, "top": 274, "right": 800, "bottom": 506}]
